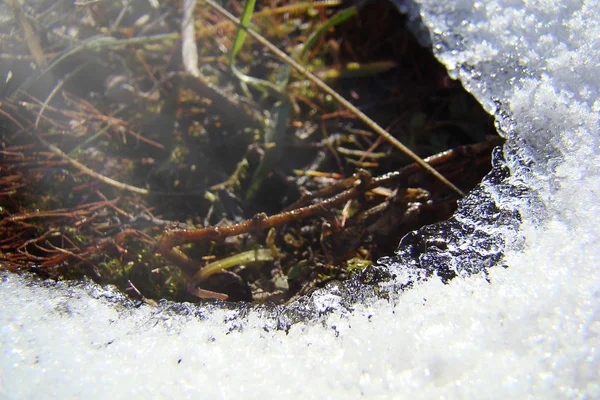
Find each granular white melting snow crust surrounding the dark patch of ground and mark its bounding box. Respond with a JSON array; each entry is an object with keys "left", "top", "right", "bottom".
[{"left": 0, "top": 0, "right": 600, "bottom": 399}]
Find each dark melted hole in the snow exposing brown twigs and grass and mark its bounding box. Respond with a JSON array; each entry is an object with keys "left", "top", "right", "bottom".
[{"left": 0, "top": 1, "right": 502, "bottom": 308}]
